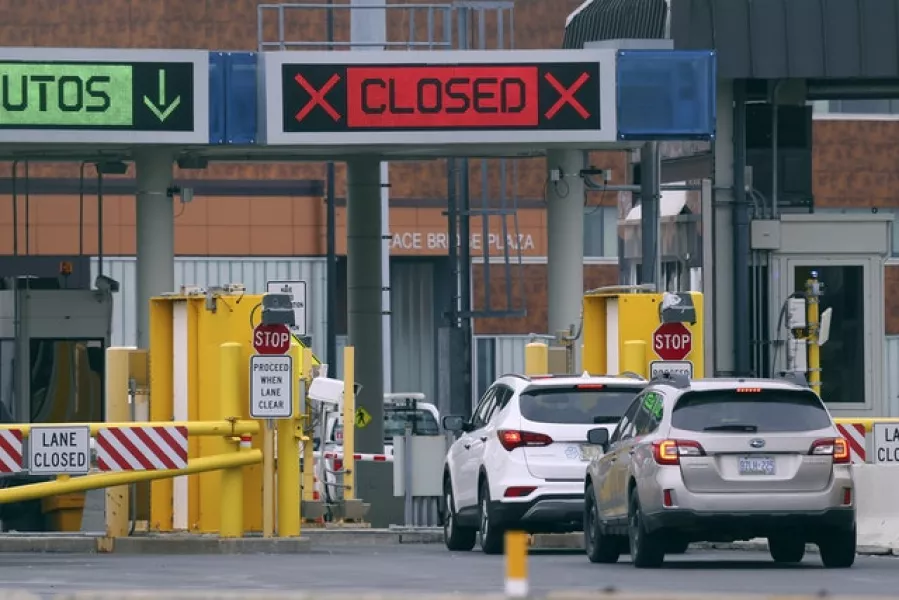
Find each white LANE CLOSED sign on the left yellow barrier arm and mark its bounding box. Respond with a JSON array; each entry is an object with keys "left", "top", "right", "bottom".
[{"left": 28, "top": 425, "right": 91, "bottom": 475}]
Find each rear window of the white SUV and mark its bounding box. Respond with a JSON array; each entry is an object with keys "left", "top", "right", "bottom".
[{"left": 518, "top": 386, "right": 643, "bottom": 425}]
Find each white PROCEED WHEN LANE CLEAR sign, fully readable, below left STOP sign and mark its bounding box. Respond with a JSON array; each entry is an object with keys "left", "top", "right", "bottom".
[{"left": 250, "top": 354, "right": 293, "bottom": 419}]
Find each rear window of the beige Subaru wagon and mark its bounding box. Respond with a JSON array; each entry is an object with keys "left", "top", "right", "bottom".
[{"left": 671, "top": 389, "right": 831, "bottom": 433}]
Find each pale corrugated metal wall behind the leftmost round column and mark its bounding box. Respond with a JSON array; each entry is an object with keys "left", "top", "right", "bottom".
[{"left": 91, "top": 256, "right": 327, "bottom": 361}]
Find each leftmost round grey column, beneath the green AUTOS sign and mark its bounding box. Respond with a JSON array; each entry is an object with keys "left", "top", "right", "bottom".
[{"left": 134, "top": 150, "right": 175, "bottom": 348}]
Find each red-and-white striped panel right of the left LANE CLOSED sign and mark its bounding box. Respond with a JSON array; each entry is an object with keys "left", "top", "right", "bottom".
[{"left": 97, "top": 426, "right": 187, "bottom": 471}]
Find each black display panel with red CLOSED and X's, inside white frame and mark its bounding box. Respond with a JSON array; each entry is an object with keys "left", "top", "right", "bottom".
[{"left": 281, "top": 61, "right": 602, "bottom": 133}]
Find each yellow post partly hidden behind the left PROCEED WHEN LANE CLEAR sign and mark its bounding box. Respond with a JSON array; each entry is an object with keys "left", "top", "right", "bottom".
[{"left": 277, "top": 341, "right": 302, "bottom": 537}]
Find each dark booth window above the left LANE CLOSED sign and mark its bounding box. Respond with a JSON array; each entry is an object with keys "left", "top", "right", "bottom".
[{"left": 29, "top": 338, "right": 105, "bottom": 423}]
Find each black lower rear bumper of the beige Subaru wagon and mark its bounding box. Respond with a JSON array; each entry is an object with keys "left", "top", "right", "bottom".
[{"left": 644, "top": 507, "right": 855, "bottom": 542}]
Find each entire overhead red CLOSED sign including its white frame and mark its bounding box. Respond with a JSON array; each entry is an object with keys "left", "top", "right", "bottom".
[{"left": 260, "top": 49, "right": 618, "bottom": 151}]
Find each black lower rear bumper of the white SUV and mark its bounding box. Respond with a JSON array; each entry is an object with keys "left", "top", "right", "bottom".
[{"left": 490, "top": 494, "right": 584, "bottom": 533}]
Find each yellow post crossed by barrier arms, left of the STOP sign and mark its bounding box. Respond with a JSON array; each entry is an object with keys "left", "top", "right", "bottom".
[{"left": 218, "top": 342, "right": 243, "bottom": 538}]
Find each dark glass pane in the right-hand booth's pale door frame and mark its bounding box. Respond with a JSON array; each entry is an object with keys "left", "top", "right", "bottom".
[{"left": 793, "top": 265, "right": 867, "bottom": 404}]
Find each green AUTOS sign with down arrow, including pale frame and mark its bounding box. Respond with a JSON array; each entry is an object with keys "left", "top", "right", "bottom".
[{"left": 0, "top": 49, "right": 209, "bottom": 143}]
